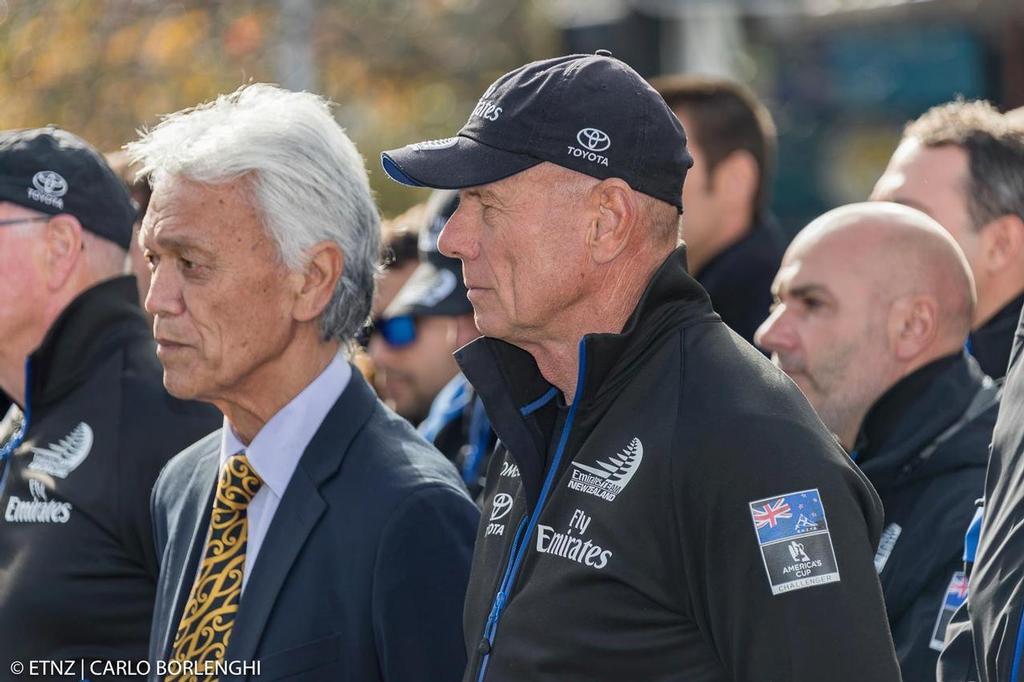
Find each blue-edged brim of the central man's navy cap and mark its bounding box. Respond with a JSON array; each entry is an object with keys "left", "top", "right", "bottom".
[{"left": 381, "top": 135, "right": 541, "bottom": 189}]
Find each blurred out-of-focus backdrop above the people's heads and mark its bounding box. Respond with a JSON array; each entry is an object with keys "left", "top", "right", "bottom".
[{"left": 0, "top": 0, "right": 1024, "bottom": 225}]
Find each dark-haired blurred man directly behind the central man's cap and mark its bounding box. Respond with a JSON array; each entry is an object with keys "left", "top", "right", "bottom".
[{"left": 652, "top": 76, "right": 785, "bottom": 341}]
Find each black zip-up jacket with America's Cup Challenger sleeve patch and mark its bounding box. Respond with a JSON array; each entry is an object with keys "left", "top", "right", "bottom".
[{"left": 457, "top": 249, "right": 899, "bottom": 682}]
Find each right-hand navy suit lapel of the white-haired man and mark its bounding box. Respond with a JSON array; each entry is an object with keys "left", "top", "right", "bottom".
[{"left": 224, "top": 369, "right": 377, "bottom": 660}]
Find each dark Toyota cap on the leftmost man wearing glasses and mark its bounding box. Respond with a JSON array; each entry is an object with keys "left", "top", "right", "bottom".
[{"left": 0, "top": 126, "right": 135, "bottom": 249}]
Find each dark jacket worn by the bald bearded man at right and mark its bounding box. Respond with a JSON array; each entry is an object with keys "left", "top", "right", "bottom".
[{"left": 855, "top": 352, "right": 998, "bottom": 682}]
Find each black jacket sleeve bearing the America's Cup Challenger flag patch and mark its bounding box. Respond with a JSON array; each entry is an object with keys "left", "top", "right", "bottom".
[{"left": 676, "top": 416, "right": 900, "bottom": 682}]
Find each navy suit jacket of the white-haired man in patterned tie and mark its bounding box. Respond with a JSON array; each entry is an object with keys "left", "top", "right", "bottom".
[{"left": 150, "top": 371, "right": 479, "bottom": 682}]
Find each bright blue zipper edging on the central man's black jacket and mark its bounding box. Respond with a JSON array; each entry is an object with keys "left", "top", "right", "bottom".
[{"left": 476, "top": 346, "right": 587, "bottom": 682}]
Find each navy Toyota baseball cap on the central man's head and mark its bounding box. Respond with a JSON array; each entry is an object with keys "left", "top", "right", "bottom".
[{"left": 381, "top": 50, "right": 693, "bottom": 211}]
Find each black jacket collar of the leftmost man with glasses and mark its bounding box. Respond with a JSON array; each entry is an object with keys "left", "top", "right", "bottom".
[{"left": 27, "top": 275, "right": 150, "bottom": 408}]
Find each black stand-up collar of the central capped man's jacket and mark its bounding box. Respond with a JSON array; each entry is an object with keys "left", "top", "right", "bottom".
[{"left": 456, "top": 247, "right": 716, "bottom": 502}]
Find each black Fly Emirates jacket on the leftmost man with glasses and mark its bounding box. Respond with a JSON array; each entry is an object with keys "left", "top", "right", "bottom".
[{"left": 0, "top": 276, "right": 221, "bottom": 681}]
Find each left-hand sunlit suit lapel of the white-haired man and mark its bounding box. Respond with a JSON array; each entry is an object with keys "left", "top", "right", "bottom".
[{"left": 161, "top": 438, "right": 220, "bottom": 660}]
